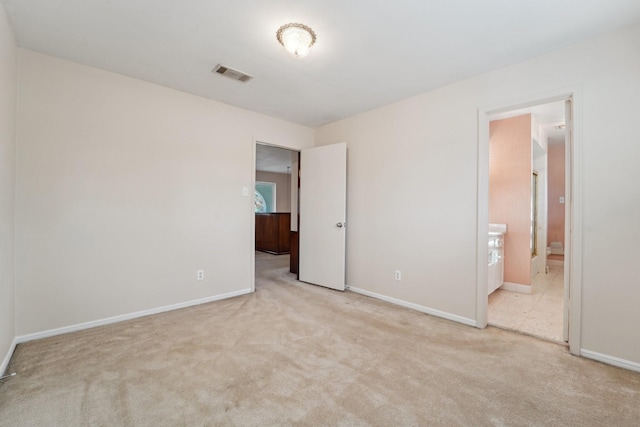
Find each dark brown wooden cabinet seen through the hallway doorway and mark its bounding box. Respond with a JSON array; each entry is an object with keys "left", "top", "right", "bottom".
[{"left": 256, "top": 212, "right": 291, "bottom": 255}]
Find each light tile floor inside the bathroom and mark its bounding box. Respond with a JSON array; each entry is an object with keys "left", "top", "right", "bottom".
[{"left": 488, "top": 266, "right": 564, "bottom": 343}]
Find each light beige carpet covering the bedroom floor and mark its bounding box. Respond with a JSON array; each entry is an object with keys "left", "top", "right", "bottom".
[{"left": 0, "top": 254, "right": 640, "bottom": 426}]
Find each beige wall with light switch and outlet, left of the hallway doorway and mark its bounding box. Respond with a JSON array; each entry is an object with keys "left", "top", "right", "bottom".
[{"left": 16, "top": 49, "right": 313, "bottom": 335}]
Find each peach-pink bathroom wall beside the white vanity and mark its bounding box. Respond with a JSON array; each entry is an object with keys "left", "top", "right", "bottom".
[{"left": 489, "top": 114, "right": 532, "bottom": 285}]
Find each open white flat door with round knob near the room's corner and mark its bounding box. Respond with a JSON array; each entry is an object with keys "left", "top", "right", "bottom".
[{"left": 298, "top": 143, "right": 347, "bottom": 291}]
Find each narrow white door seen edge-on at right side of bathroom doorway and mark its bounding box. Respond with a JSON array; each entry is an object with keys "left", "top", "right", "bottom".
[{"left": 562, "top": 99, "right": 573, "bottom": 342}]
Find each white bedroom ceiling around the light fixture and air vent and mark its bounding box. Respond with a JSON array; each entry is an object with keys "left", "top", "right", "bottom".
[{"left": 0, "top": 0, "right": 640, "bottom": 127}]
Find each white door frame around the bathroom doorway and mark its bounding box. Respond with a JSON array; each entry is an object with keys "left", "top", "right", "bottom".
[{"left": 476, "top": 86, "right": 583, "bottom": 355}]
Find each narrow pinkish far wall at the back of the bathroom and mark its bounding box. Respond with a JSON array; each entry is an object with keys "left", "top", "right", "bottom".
[{"left": 547, "top": 143, "right": 565, "bottom": 247}]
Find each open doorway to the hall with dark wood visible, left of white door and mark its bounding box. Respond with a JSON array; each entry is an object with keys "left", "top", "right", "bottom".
[{"left": 253, "top": 143, "right": 299, "bottom": 287}]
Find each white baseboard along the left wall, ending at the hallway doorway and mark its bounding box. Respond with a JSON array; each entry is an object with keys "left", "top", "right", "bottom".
[{"left": 14, "top": 289, "right": 252, "bottom": 345}]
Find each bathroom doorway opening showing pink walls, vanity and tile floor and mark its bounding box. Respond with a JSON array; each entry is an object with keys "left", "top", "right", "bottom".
[{"left": 488, "top": 101, "right": 568, "bottom": 343}]
